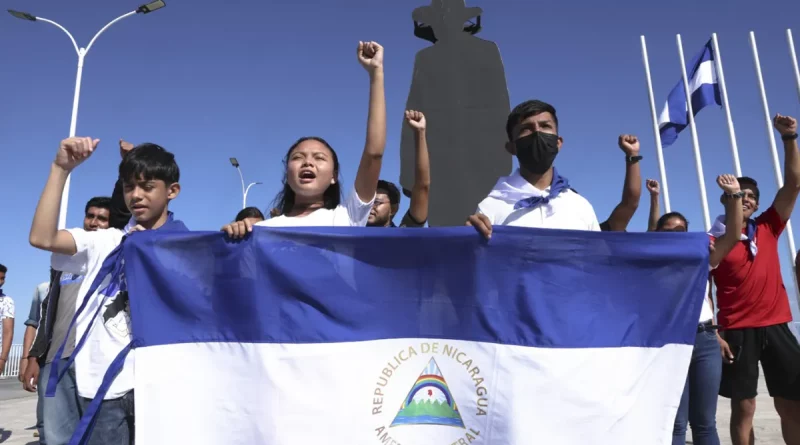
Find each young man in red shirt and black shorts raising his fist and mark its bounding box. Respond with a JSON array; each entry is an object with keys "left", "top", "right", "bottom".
[{"left": 711, "top": 115, "right": 800, "bottom": 445}]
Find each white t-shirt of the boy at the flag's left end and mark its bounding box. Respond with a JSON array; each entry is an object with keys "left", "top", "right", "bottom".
[{"left": 50, "top": 223, "right": 134, "bottom": 400}]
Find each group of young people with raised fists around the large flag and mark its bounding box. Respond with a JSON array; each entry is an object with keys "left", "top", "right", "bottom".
[{"left": 0, "top": 42, "right": 800, "bottom": 444}]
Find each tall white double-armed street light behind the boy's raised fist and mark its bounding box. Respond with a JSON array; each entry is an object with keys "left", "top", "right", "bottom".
[{"left": 8, "top": 0, "right": 167, "bottom": 229}]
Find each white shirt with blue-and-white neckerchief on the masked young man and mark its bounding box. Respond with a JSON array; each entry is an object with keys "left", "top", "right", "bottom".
[{"left": 478, "top": 170, "right": 600, "bottom": 232}]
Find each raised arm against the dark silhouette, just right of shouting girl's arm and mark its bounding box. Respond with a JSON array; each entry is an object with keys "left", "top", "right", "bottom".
[{"left": 406, "top": 110, "right": 431, "bottom": 223}]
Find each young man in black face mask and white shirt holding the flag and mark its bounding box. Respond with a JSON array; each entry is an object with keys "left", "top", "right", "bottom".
[{"left": 467, "top": 100, "right": 600, "bottom": 238}]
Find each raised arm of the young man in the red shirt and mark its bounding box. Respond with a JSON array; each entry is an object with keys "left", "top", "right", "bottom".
[{"left": 772, "top": 114, "right": 800, "bottom": 222}]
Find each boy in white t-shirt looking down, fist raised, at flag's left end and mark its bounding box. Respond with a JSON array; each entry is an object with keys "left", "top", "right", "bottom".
[{"left": 30, "top": 137, "right": 185, "bottom": 445}]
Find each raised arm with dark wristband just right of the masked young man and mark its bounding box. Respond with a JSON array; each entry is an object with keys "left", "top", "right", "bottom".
[{"left": 605, "top": 134, "right": 642, "bottom": 232}]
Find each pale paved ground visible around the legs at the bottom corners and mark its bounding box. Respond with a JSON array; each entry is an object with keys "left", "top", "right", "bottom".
[{"left": 0, "top": 379, "right": 783, "bottom": 445}]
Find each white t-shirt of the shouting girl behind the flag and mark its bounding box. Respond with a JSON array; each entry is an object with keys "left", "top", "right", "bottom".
[{"left": 256, "top": 188, "right": 375, "bottom": 227}]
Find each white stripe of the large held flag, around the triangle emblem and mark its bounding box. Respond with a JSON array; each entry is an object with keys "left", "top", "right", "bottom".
[{"left": 135, "top": 339, "right": 692, "bottom": 445}]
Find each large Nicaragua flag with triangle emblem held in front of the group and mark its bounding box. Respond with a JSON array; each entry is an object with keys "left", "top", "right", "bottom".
[{"left": 112, "top": 227, "right": 708, "bottom": 445}]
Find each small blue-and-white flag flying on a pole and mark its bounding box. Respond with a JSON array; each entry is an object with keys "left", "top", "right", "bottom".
[{"left": 658, "top": 40, "right": 722, "bottom": 147}]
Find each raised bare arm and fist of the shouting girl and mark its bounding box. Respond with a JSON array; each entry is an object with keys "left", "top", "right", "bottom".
[{"left": 355, "top": 42, "right": 386, "bottom": 202}]
